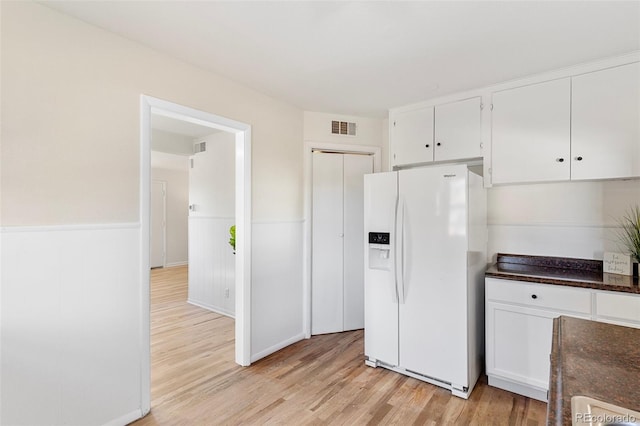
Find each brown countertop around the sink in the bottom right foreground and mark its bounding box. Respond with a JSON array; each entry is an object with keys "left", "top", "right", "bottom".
[{"left": 547, "top": 316, "right": 640, "bottom": 425}]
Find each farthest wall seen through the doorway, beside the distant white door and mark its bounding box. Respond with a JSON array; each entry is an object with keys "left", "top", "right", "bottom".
[{"left": 151, "top": 151, "right": 189, "bottom": 267}]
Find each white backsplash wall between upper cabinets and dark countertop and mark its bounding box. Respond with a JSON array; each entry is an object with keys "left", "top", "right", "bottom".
[{"left": 487, "top": 180, "right": 640, "bottom": 262}]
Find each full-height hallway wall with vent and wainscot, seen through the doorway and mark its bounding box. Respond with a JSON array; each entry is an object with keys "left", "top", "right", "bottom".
[{"left": 188, "top": 132, "right": 236, "bottom": 316}]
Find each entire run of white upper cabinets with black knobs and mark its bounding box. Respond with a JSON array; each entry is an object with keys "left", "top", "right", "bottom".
[{"left": 389, "top": 54, "right": 640, "bottom": 184}]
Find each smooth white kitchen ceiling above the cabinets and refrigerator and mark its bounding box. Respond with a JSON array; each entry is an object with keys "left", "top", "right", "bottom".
[{"left": 43, "top": 1, "right": 640, "bottom": 117}]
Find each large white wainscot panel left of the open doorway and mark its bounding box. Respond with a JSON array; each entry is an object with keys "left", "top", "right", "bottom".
[{"left": 0, "top": 224, "right": 141, "bottom": 425}]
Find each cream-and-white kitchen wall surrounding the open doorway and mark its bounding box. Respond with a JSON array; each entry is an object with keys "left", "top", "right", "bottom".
[{"left": 0, "top": 2, "right": 303, "bottom": 425}]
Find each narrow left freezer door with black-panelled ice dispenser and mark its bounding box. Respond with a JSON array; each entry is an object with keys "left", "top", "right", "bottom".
[{"left": 363, "top": 172, "right": 398, "bottom": 366}]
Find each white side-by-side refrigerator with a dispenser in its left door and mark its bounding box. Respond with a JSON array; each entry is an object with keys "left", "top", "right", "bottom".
[{"left": 364, "top": 164, "right": 487, "bottom": 399}]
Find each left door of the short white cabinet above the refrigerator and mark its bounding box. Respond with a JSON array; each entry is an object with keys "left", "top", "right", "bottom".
[{"left": 391, "top": 107, "right": 433, "bottom": 166}]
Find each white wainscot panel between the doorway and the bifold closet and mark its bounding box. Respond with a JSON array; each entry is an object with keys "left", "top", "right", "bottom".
[{"left": 251, "top": 221, "right": 304, "bottom": 362}]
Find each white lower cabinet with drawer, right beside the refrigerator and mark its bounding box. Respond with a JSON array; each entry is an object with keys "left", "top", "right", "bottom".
[{"left": 485, "top": 278, "right": 591, "bottom": 401}]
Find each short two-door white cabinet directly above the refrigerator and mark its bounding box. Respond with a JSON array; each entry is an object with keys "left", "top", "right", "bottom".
[{"left": 391, "top": 97, "right": 482, "bottom": 166}]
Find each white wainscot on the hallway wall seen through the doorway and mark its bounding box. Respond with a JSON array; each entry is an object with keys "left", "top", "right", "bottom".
[{"left": 188, "top": 216, "right": 236, "bottom": 317}]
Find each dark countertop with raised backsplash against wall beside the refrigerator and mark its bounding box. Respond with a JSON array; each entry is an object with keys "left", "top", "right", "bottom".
[{"left": 485, "top": 253, "right": 640, "bottom": 294}]
